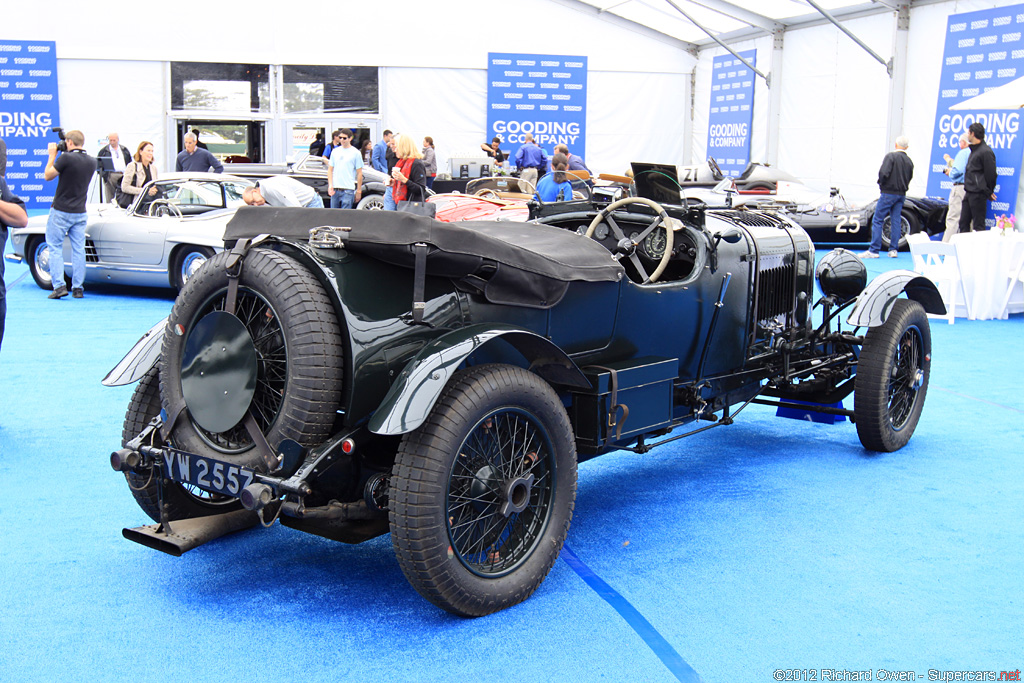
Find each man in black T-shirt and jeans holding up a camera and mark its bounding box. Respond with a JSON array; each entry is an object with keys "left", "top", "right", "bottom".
[{"left": 43, "top": 130, "right": 96, "bottom": 299}]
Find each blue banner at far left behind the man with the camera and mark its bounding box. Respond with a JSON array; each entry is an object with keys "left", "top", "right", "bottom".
[{"left": 0, "top": 40, "right": 60, "bottom": 209}]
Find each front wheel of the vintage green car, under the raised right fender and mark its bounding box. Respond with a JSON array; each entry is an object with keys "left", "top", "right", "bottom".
[{"left": 853, "top": 299, "right": 932, "bottom": 453}]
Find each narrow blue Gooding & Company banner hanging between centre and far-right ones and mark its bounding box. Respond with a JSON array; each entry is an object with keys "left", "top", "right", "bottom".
[{"left": 708, "top": 50, "right": 758, "bottom": 177}]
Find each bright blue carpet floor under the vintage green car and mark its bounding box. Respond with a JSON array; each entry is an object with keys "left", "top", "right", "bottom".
[{"left": 0, "top": 242, "right": 1024, "bottom": 683}]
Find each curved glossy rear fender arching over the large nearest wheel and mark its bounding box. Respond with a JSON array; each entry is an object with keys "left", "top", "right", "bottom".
[{"left": 369, "top": 324, "right": 590, "bottom": 435}]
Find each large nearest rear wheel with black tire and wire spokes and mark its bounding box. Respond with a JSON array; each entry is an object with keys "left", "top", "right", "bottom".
[{"left": 389, "top": 365, "right": 577, "bottom": 616}]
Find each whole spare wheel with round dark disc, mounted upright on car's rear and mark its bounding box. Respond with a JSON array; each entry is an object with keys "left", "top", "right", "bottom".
[{"left": 160, "top": 249, "right": 342, "bottom": 470}]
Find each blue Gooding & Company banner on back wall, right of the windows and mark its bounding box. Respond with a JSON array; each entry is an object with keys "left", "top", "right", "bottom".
[{"left": 483, "top": 52, "right": 587, "bottom": 165}]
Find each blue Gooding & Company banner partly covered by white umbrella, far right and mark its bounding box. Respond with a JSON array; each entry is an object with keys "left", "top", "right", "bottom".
[{"left": 928, "top": 5, "right": 1024, "bottom": 226}]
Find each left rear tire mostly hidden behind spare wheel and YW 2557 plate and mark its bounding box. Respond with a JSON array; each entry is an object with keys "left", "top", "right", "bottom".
[{"left": 121, "top": 368, "right": 242, "bottom": 522}]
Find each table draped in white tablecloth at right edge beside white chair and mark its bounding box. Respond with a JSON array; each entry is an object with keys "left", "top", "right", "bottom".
[{"left": 950, "top": 230, "right": 1024, "bottom": 321}]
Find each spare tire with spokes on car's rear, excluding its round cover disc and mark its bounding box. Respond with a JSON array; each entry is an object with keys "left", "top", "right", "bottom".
[{"left": 160, "top": 249, "right": 342, "bottom": 470}]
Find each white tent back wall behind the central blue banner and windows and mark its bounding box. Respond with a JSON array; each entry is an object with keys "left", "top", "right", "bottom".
[{"left": 3, "top": 0, "right": 696, "bottom": 173}]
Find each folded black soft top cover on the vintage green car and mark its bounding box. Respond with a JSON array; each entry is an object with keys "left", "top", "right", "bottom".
[{"left": 224, "top": 206, "right": 623, "bottom": 308}]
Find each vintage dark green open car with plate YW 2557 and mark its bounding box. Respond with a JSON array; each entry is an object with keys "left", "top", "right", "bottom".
[{"left": 104, "top": 198, "right": 944, "bottom": 615}]
